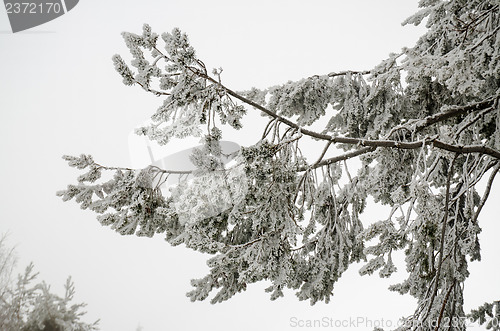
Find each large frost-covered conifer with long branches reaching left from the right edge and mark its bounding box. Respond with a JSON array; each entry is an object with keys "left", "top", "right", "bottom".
[{"left": 58, "top": 0, "right": 500, "bottom": 330}]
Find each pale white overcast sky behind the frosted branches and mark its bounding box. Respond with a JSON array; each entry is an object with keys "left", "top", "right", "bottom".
[{"left": 0, "top": 0, "right": 500, "bottom": 331}]
